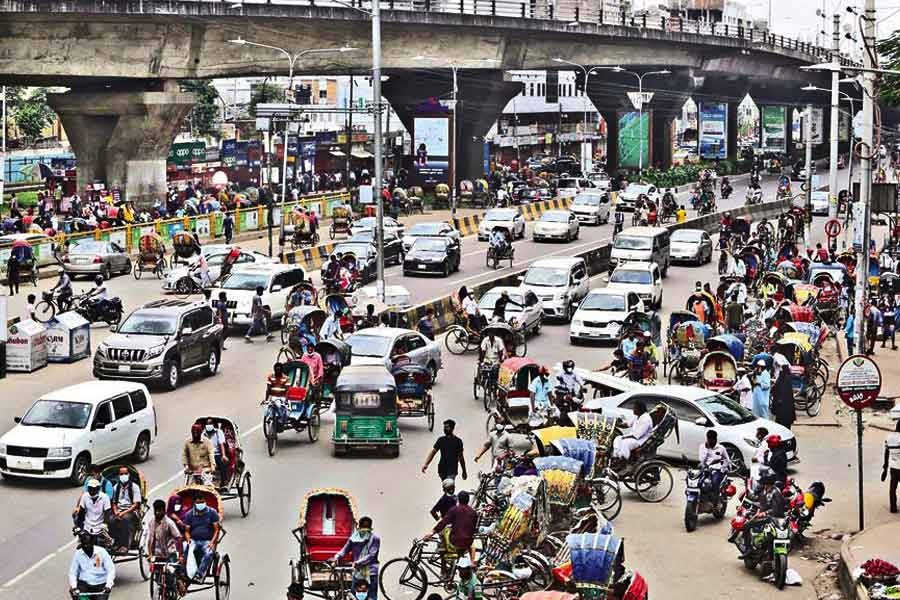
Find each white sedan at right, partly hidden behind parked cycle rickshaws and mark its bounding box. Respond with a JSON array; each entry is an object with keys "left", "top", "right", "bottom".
[{"left": 582, "top": 385, "right": 797, "bottom": 472}]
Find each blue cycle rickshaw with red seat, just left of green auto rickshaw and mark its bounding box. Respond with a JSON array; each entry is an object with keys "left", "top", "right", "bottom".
[{"left": 262, "top": 360, "right": 327, "bottom": 456}]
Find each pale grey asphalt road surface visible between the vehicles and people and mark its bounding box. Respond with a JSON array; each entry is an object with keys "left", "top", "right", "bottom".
[{"left": 0, "top": 165, "right": 887, "bottom": 600}]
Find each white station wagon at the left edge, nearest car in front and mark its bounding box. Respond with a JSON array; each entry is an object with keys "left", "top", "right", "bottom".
[{"left": 0, "top": 381, "right": 156, "bottom": 485}]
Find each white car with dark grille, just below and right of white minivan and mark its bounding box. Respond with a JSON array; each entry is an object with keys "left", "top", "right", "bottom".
[{"left": 569, "top": 287, "right": 644, "bottom": 344}]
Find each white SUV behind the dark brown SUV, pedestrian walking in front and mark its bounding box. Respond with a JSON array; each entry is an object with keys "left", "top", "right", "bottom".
[{"left": 211, "top": 264, "right": 305, "bottom": 329}]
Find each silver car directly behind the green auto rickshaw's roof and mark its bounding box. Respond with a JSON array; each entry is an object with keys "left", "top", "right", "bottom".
[{"left": 345, "top": 327, "right": 443, "bottom": 381}]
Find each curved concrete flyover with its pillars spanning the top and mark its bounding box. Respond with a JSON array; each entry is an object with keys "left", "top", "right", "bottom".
[{"left": 0, "top": 0, "right": 852, "bottom": 203}]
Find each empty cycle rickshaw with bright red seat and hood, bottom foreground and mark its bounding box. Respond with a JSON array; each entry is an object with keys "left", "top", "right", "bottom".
[{"left": 287, "top": 488, "right": 359, "bottom": 600}]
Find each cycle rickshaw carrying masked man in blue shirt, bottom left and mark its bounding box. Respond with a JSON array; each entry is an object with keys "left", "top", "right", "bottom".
[{"left": 160, "top": 484, "right": 231, "bottom": 600}]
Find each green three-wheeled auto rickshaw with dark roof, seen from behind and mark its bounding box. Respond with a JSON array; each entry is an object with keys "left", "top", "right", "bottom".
[{"left": 331, "top": 365, "right": 402, "bottom": 457}]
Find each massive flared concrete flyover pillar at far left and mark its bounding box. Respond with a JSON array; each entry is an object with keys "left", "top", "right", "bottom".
[{"left": 48, "top": 80, "right": 194, "bottom": 207}]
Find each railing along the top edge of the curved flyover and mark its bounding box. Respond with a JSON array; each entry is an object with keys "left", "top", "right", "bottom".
[{"left": 223, "top": 0, "right": 852, "bottom": 64}]
